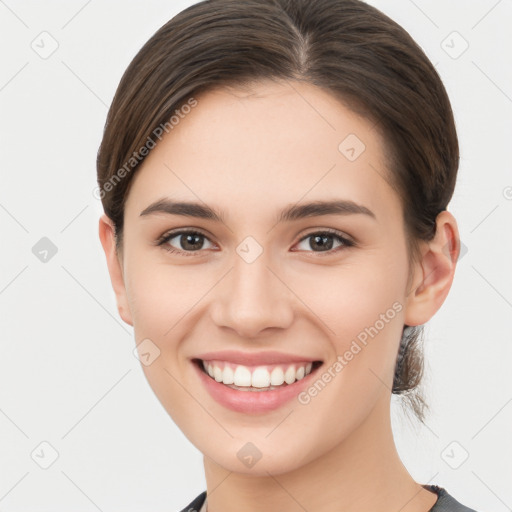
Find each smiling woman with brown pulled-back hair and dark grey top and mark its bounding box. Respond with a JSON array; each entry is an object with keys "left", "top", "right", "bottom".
[{"left": 97, "top": 0, "right": 480, "bottom": 512}]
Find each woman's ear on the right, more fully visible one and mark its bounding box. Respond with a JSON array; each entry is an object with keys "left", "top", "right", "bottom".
[{"left": 404, "top": 210, "right": 460, "bottom": 326}]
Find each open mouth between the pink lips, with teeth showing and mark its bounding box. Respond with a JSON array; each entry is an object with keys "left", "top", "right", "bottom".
[{"left": 192, "top": 359, "right": 323, "bottom": 393}]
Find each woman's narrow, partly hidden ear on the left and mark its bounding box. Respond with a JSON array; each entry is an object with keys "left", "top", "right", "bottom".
[{"left": 99, "top": 214, "right": 133, "bottom": 325}]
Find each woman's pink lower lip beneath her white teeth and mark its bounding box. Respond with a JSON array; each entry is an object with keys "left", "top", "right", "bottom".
[{"left": 193, "top": 361, "right": 320, "bottom": 414}]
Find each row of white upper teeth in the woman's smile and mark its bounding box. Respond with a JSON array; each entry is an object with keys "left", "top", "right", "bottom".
[{"left": 202, "top": 361, "right": 313, "bottom": 389}]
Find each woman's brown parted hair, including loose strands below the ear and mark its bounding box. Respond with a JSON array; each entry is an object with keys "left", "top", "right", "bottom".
[{"left": 97, "top": 0, "right": 459, "bottom": 421}]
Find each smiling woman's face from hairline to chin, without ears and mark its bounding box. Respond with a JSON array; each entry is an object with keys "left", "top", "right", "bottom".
[{"left": 104, "top": 82, "right": 420, "bottom": 475}]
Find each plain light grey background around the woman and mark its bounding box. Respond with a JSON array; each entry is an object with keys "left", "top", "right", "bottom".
[{"left": 0, "top": 0, "right": 512, "bottom": 512}]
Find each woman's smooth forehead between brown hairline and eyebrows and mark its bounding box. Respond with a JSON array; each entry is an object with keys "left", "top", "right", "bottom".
[{"left": 127, "top": 80, "right": 393, "bottom": 216}]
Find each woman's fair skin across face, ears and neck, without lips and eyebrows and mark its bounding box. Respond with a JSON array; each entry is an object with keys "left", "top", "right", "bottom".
[{"left": 99, "top": 82, "right": 460, "bottom": 512}]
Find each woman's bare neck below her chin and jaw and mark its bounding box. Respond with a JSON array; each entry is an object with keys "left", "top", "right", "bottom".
[{"left": 204, "top": 394, "right": 437, "bottom": 512}]
